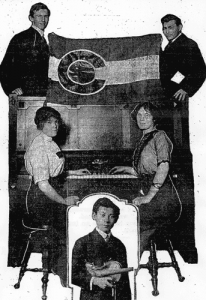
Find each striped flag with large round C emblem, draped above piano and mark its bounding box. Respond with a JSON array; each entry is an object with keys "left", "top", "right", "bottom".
[{"left": 47, "top": 33, "right": 163, "bottom": 105}]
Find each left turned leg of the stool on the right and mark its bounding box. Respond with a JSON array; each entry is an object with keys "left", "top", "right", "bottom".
[{"left": 149, "top": 240, "right": 159, "bottom": 296}]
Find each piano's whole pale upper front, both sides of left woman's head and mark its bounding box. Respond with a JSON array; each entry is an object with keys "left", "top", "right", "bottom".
[{"left": 16, "top": 97, "right": 137, "bottom": 151}]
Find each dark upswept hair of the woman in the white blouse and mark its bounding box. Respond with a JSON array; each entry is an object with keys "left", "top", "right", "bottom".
[{"left": 34, "top": 106, "right": 62, "bottom": 130}]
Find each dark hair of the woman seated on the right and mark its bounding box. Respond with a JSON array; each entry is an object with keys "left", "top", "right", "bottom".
[{"left": 131, "top": 102, "right": 162, "bottom": 124}]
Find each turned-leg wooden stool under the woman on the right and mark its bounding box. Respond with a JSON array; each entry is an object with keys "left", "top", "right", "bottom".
[{"left": 139, "top": 228, "right": 185, "bottom": 296}]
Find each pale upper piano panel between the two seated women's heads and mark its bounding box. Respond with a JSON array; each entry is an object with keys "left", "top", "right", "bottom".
[{"left": 48, "top": 103, "right": 134, "bottom": 151}]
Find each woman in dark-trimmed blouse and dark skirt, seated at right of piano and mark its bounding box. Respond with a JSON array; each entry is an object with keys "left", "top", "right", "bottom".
[{"left": 110, "top": 102, "right": 181, "bottom": 254}]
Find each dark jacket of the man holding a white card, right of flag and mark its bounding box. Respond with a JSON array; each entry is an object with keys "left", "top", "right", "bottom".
[{"left": 160, "top": 34, "right": 206, "bottom": 98}]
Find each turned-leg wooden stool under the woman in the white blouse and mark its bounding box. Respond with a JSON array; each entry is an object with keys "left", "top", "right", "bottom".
[{"left": 14, "top": 220, "right": 51, "bottom": 300}]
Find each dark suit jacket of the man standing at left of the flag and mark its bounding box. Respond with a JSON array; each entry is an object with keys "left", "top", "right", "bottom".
[{"left": 0, "top": 27, "right": 49, "bottom": 96}]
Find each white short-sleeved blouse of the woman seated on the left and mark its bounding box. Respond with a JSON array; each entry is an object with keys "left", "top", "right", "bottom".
[{"left": 24, "top": 132, "right": 65, "bottom": 183}]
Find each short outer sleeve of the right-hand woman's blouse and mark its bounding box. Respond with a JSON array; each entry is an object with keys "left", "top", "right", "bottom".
[{"left": 154, "top": 131, "right": 173, "bottom": 165}]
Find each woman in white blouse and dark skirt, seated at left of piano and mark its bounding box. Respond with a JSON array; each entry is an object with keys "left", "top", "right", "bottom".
[{"left": 24, "top": 106, "right": 89, "bottom": 284}]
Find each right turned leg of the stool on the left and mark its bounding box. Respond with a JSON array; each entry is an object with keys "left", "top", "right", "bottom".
[{"left": 41, "top": 241, "right": 49, "bottom": 300}]
